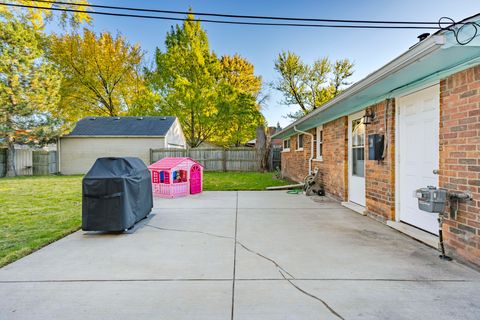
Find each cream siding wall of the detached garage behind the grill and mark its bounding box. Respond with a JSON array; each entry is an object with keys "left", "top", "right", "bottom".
[{"left": 59, "top": 137, "right": 165, "bottom": 174}]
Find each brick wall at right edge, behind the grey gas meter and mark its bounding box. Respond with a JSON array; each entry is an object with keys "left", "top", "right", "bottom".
[{"left": 439, "top": 66, "right": 480, "bottom": 266}]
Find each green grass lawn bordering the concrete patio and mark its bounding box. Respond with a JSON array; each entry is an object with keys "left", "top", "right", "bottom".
[{"left": 0, "top": 172, "right": 288, "bottom": 267}]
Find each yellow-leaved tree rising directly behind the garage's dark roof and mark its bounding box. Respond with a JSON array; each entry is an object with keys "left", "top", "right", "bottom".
[{"left": 50, "top": 29, "right": 149, "bottom": 123}]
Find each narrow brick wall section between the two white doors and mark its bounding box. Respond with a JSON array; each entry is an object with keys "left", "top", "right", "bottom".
[{"left": 365, "top": 99, "right": 395, "bottom": 222}]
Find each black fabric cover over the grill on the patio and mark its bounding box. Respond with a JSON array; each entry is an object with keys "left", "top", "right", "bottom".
[{"left": 82, "top": 157, "right": 153, "bottom": 231}]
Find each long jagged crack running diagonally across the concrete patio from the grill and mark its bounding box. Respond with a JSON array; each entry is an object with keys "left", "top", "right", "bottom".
[{"left": 146, "top": 224, "right": 345, "bottom": 320}]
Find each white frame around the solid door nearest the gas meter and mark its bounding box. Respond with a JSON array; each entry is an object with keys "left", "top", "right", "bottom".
[{"left": 394, "top": 81, "right": 442, "bottom": 222}]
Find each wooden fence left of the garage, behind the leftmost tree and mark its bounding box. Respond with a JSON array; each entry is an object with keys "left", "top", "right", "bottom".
[{"left": 0, "top": 149, "right": 58, "bottom": 177}]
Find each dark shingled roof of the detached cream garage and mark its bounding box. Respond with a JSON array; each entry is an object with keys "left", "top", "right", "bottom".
[{"left": 67, "top": 117, "right": 176, "bottom": 137}]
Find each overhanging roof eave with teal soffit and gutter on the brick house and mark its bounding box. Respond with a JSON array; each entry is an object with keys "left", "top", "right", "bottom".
[{"left": 273, "top": 15, "right": 480, "bottom": 139}]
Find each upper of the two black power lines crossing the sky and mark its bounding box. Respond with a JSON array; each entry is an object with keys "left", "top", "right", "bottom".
[{"left": 31, "top": 0, "right": 450, "bottom": 26}]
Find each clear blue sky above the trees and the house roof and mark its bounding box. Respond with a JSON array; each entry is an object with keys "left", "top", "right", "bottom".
[{"left": 50, "top": 0, "right": 480, "bottom": 126}]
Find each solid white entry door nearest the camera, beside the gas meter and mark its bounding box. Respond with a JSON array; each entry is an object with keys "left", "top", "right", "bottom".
[{"left": 397, "top": 85, "right": 440, "bottom": 234}]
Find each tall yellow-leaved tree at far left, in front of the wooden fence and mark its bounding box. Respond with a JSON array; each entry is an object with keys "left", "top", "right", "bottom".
[{"left": 0, "top": 0, "right": 89, "bottom": 176}]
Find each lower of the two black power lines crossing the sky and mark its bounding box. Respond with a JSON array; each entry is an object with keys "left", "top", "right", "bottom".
[{"left": 0, "top": 0, "right": 438, "bottom": 30}]
